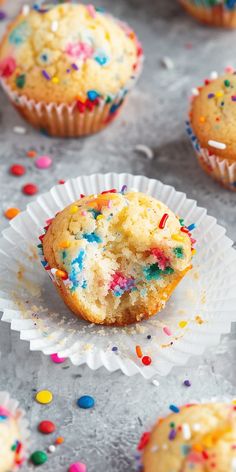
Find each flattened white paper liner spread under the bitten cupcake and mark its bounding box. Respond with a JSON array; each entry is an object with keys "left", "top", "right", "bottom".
[{"left": 0, "top": 173, "right": 236, "bottom": 378}]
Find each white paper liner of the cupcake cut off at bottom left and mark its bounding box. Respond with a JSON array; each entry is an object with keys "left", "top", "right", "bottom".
[{"left": 0, "top": 391, "right": 30, "bottom": 471}]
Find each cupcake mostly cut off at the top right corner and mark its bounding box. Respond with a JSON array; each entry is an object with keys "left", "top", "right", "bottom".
[{"left": 180, "top": 0, "right": 236, "bottom": 28}]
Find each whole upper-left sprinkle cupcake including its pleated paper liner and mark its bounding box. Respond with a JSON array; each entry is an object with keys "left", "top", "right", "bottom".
[{"left": 0, "top": 3, "right": 143, "bottom": 137}]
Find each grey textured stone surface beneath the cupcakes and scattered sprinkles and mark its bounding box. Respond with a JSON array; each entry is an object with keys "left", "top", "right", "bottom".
[{"left": 0, "top": 0, "right": 236, "bottom": 472}]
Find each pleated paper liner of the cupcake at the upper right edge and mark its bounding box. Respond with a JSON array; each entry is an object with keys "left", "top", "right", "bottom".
[{"left": 186, "top": 121, "right": 236, "bottom": 191}]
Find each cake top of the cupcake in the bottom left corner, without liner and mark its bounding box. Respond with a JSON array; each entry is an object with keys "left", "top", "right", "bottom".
[{"left": 0, "top": 405, "right": 23, "bottom": 472}]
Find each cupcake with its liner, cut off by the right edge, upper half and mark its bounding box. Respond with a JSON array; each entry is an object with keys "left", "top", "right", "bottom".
[{"left": 187, "top": 73, "right": 236, "bottom": 191}]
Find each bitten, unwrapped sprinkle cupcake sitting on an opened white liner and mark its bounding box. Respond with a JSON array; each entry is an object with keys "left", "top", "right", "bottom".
[{"left": 39, "top": 186, "right": 194, "bottom": 326}]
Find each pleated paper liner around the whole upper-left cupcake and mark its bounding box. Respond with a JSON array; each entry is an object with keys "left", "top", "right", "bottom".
[{"left": 1, "top": 56, "right": 143, "bottom": 137}]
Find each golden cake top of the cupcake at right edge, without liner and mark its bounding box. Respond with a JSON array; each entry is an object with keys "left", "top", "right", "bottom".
[{"left": 190, "top": 73, "right": 236, "bottom": 162}]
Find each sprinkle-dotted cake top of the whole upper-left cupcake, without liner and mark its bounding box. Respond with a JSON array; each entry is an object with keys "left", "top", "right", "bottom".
[{"left": 0, "top": 3, "right": 142, "bottom": 103}]
